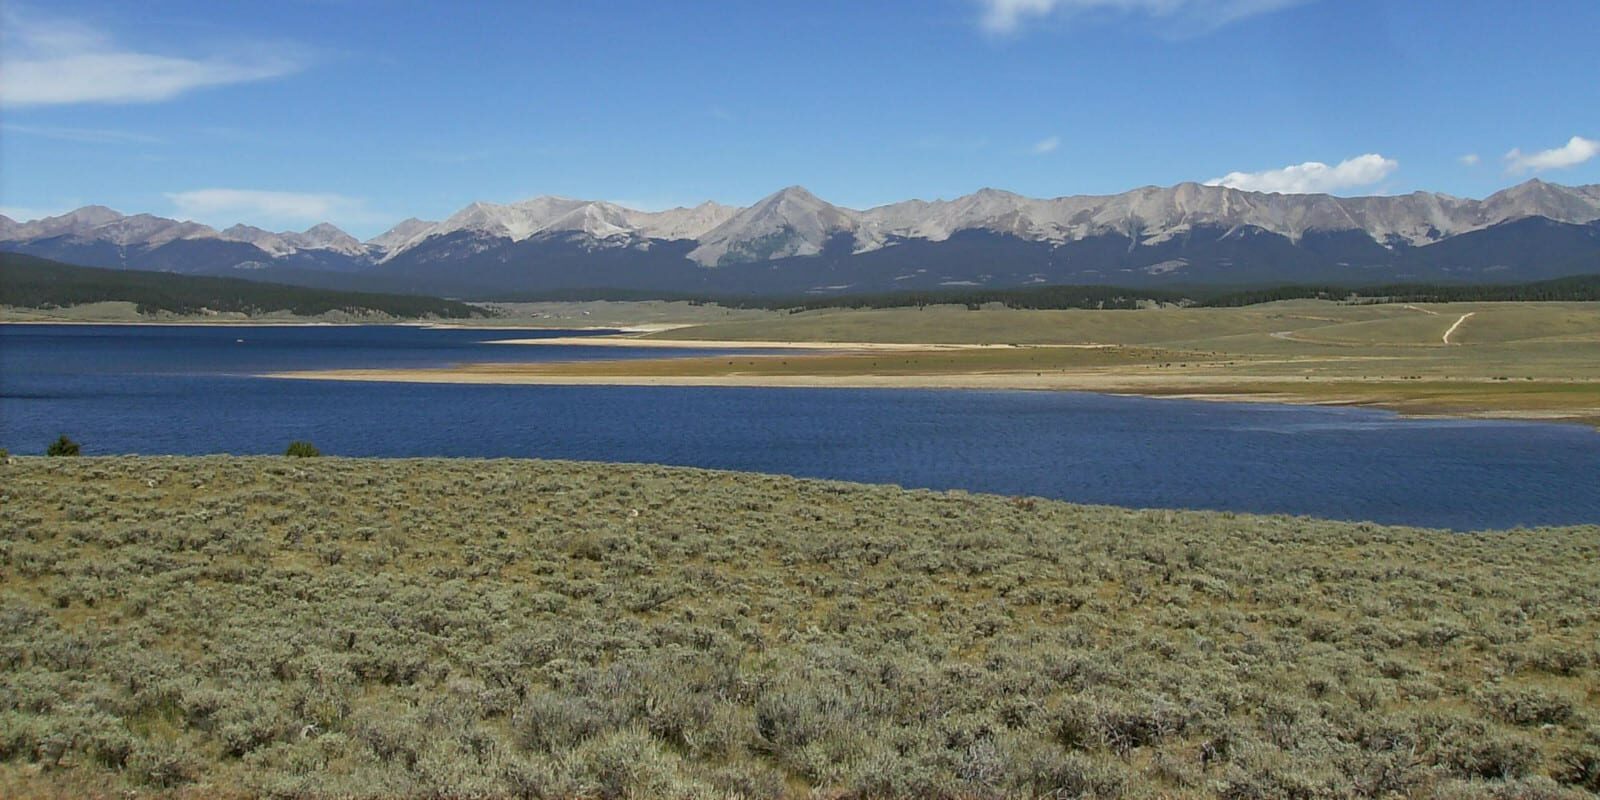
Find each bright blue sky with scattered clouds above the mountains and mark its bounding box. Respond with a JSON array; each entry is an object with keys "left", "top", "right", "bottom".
[{"left": 0, "top": 0, "right": 1600, "bottom": 238}]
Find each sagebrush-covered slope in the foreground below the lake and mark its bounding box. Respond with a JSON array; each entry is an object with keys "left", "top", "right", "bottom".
[{"left": 0, "top": 458, "right": 1600, "bottom": 798}]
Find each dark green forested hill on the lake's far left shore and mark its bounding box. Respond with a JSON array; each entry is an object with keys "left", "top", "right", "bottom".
[{"left": 0, "top": 253, "right": 486, "bottom": 318}]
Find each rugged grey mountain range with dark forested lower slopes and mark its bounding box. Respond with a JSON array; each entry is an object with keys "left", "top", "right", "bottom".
[{"left": 0, "top": 179, "right": 1600, "bottom": 298}]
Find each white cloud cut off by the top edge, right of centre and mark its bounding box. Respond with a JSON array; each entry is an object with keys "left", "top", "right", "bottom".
[{"left": 978, "top": 0, "right": 1306, "bottom": 35}]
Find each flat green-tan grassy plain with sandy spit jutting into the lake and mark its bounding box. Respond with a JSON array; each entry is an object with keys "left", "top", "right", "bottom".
[{"left": 272, "top": 301, "right": 1600, "bottom": 424}]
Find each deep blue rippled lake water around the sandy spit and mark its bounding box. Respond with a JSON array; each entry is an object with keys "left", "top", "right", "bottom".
[{"left": 0, "top": 325, "right": 1600, "bottom": 530}]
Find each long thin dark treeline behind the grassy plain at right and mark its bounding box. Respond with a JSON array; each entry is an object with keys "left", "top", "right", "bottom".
[{"left": 489, "top": 275, "right": 1600, "bottom": 310}]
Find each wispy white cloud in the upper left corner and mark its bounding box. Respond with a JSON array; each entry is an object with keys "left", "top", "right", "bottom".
[{"left": 0, "top": 10, "right": 306, "bottom": 107}]
